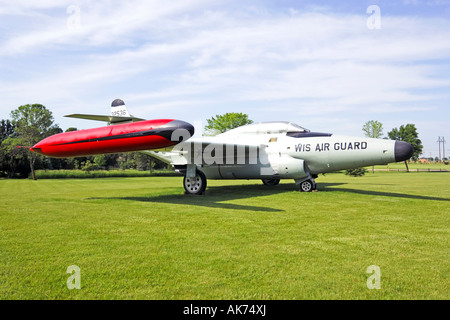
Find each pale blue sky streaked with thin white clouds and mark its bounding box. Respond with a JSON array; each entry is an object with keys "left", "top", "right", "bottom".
[{"left": 0, "top": 0, "right": 450, "bottom": 157}]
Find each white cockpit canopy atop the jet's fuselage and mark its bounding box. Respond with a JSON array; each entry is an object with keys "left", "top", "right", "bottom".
[{"left": 223, "top": 121, "right": 310, "bottom": 135}]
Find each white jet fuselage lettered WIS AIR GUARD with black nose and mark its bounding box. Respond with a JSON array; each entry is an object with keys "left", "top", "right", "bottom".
[{"left": 168, "top": 127, "right": 413, "bottom": 181}]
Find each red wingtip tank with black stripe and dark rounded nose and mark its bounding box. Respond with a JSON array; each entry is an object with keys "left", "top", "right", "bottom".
[{"left": 30, "top": 119, "right": 194, "bottom": 158}]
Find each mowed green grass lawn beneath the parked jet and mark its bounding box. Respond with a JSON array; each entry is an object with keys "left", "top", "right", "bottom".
[{"left": 0, "top": 172, "right": 450, "bottom": 299}]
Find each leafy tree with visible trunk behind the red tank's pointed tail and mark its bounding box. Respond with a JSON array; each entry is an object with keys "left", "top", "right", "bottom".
[{"left": 11, "top": 104, "right": 62, "bottom": 180}]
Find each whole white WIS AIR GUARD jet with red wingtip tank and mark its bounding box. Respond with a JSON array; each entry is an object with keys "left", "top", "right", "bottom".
[{"left": 30, "top": 99, "right": 414, "bottom": 195}]
